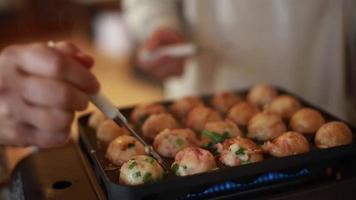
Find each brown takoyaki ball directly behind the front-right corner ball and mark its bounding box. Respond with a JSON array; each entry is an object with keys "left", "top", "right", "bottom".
[{"left": 289, "top": 108, "right": 325, "bottom": 134}]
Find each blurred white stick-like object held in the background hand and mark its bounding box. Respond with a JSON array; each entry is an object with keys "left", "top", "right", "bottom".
[{"left": 140, "top": 43, "right": 197, "bottom": 61}]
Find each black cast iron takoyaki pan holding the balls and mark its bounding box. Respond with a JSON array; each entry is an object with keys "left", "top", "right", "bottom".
[{"left": 78, "top": 88, "right": 356, "bottom": 199}]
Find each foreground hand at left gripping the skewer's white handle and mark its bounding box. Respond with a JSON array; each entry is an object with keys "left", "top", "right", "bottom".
[{"left": 0, "top": 42, "right": 99, "bottom": 147}]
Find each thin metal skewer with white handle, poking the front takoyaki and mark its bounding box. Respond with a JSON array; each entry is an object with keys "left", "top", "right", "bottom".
[{"left": 90, "top": 92, "right": 169, "bottom": 171}]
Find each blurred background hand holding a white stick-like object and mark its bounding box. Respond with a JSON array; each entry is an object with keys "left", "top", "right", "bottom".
[{"left": 138, "top": 28, "right": 185, "bottom": 80}]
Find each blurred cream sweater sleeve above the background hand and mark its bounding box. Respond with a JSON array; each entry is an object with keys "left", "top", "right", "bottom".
[{"left": 122, "top": 0, "right": 180, "bottom": 42}]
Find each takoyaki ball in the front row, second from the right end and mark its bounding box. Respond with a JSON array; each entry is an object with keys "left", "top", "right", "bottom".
[{"left": 262, "top": 131, "right": 309, "bottom": 157}]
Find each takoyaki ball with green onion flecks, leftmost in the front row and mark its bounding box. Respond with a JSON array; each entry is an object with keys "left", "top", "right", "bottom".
[{"left": 119, "top": 155, "right": 164, "bottom": 185}]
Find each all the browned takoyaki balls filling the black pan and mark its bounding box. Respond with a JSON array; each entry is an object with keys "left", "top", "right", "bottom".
[{"left": 89, "top": 85, "right": 352, "bottom": 185}]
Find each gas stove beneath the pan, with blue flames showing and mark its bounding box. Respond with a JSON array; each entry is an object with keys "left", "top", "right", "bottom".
[{"left": 6, "top": 144, "right": 356, "bottom": 200}]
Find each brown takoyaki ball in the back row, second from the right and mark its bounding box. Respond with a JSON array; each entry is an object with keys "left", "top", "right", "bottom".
[{"left": 211, "top": 91, "right": 242, "bottom": 114}]
